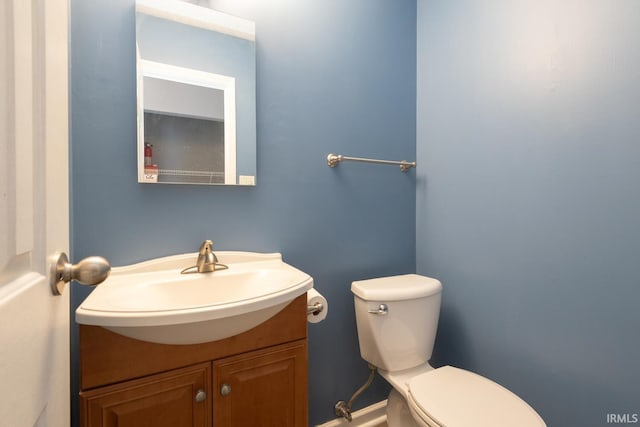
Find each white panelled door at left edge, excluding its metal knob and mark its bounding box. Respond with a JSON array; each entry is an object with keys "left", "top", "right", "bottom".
[{"left": 0, "top": 0, "right": 70, "bottom": 427}]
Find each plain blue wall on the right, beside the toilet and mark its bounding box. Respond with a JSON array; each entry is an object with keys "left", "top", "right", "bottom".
[{"left": 417, "top": 0, "right": 640, "bottom": 426}]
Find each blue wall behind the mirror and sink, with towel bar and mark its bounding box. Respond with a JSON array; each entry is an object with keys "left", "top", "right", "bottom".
[{"left": 71, "top": 0, "right": 416, "bottom": 424}]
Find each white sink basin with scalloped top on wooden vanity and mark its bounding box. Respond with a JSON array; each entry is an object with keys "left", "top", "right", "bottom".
[{"left": 76, "top": 251, "right": 313, "bottom": 344}]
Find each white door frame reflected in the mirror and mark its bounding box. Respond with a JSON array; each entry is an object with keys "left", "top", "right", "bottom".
[{"left": 137, "top": 57, "right": 236, "bottom": 184}]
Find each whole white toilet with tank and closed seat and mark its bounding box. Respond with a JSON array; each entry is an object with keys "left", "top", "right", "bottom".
[{"left": 351, "top": 274, "right": 546, "bottom": 427}]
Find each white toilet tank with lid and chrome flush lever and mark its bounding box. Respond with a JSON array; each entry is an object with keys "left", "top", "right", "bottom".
[{"left": 351, "top": 274, "right": 442, "bottom": 371}]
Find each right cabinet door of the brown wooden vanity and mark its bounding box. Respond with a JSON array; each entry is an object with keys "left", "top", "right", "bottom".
[{"left": 213, "top": 340, "right": 308, "bottom": 427}]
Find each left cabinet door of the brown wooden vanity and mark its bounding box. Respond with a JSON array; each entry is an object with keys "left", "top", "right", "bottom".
[{"left": 80, "top": 363, "right": 211, "bottom": 427}]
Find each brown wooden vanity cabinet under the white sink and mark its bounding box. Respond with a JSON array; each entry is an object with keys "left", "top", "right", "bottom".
[{"left": 80, "top": 295, "right": 308, "bottom": 427}]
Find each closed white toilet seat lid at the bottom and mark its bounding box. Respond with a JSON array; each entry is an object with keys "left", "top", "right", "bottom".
[{"left": 407, "top": 366, "right": 546, "bottom": 427}]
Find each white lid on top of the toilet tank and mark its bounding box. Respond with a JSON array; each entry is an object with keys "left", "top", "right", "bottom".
[{"left": 351, "top": 274, "right": 442, "bottom": 301}]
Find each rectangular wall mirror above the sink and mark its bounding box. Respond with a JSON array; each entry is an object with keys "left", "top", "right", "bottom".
[{"left": 136, "top": 0, "right": 256, "bottom": 185}]
